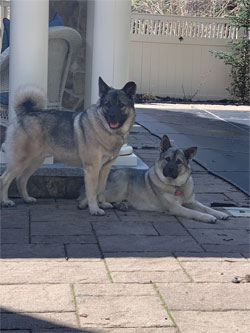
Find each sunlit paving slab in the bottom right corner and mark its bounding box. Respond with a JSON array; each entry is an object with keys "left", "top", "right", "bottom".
[{"left": 172, "top": 311, "right": 250, "bottom": 333}]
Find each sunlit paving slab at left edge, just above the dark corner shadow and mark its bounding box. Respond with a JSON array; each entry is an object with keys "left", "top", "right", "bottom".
[{"left": 0, "top": 284, "right": 75, "bottom": 312}]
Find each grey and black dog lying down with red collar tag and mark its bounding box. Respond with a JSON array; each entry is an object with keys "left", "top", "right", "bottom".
[{"left": 78, "top": 135, "right": 228, "bottom": 223}]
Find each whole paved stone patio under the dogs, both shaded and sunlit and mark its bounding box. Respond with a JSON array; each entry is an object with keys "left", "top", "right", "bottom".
[{"left": 0, "top": 105, "right": 250, "bottom": 333}]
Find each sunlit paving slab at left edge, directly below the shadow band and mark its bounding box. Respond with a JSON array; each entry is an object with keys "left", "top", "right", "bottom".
[{"left": 0, "top": 261, "right": 110, "bottom": 284}]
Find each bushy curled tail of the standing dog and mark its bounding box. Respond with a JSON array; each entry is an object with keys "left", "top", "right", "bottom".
[{"left": 15, "top": 86, "right": 47, "bottom": 114}]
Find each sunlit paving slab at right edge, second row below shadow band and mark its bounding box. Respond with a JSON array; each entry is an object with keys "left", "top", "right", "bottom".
[{"left": 157, "top": 283, "right": 250, "bottom": 311}]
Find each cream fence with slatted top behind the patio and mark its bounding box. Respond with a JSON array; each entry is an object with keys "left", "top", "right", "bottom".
[{"left": 129, "top": 14, "right": 237, "bottom": 100}]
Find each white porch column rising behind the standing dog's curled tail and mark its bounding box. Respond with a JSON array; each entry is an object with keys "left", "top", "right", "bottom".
[{"left": 9, "top": 0, "right": 49, "bottom": 120}]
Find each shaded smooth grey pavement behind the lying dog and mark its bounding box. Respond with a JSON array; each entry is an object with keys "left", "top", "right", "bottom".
[{"left": 136, "top": 106, "right": 250, "bottom": 194}]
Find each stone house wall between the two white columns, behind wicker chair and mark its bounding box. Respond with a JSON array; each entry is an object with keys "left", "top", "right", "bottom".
[{"left": 49, "top": 0, "right": 87, "bottom": 111}]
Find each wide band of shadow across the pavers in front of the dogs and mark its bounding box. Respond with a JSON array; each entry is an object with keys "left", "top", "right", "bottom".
[{"left": 1, "top": 200, "right": 249, "bottom": 261}]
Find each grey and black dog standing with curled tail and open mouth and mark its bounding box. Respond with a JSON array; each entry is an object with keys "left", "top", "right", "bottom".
[{"left": 0, "top": 78, "right": 136, "bottom": 215}]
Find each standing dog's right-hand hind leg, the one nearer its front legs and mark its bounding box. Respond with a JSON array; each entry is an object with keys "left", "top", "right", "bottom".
[{"left": 16, "top": 156, "right": 44, "bottom": 203}]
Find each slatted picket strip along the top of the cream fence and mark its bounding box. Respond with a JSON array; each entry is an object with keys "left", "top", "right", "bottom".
[{"left": 130, "top": 14, "right": 238, "bottom": 39}]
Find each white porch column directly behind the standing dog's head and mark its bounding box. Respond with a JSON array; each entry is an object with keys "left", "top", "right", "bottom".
[{"left": 85, "top": 0, "right": 131, "bottom": 107}]
